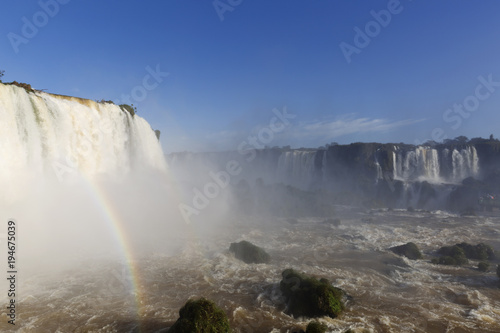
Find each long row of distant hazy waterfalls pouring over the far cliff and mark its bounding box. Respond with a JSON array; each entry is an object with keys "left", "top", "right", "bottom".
[{"left": 169, "top": 143, "right": 480, "bottom": 191}]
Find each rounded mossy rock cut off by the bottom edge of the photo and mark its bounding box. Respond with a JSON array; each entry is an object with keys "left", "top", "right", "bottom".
[{"left": 168, "top": 298, "right": 231, "bottom": 333}]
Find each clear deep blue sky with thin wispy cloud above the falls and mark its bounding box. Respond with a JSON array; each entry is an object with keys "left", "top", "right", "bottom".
[{"left": 0, "top": 0, "right": 500, "bottom": 152}]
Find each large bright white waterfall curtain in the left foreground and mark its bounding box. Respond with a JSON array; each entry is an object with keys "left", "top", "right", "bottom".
[{"left": 0, "top": 84, "right": 166, "bottom": 199}]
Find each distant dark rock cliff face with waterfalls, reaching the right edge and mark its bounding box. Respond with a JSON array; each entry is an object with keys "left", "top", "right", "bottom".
[{"left": 168, "top": 139, "right": 500, "bottom": 210}]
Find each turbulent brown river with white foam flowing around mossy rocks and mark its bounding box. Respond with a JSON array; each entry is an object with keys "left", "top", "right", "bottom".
[{"left": 0, "top": 207, "right": 500, "bottom": 332}]
